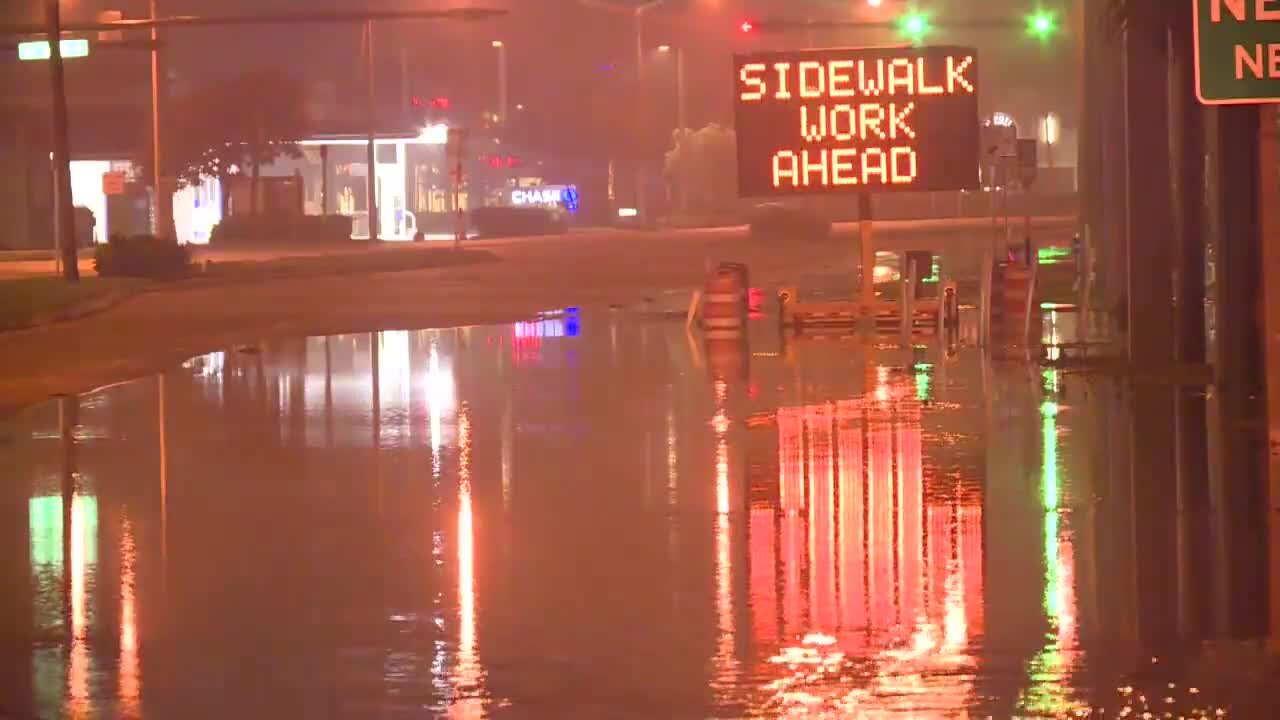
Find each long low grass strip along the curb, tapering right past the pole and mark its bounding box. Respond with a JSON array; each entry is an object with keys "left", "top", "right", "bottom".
[{"left": 0, "top": 242, "right": 498, "bottom": 332}]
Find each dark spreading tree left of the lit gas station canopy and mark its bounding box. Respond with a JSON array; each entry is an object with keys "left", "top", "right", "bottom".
[{"left": 166, "top": 69, "right": 310, "bottom": 214}]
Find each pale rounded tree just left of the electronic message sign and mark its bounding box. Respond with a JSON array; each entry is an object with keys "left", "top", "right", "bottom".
[{"left": 666, "top": 123, "right": 737, "bottom": 211}]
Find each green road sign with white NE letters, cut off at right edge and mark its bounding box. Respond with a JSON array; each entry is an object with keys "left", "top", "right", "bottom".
[{"left": 1192, "top": 0, "right": 1280, "bottom": 105}]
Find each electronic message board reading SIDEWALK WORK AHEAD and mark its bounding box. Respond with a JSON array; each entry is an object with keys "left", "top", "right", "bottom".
[{"left": 733, "top": 46, "right": 980, "bottom": 197}]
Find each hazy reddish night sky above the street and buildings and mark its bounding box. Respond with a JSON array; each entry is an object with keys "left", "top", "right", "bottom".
[{"left": 0, "top": 0, "right": 1075, "bottom": 152}]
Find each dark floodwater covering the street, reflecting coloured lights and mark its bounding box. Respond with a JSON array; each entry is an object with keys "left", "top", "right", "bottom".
[{"left": 0, "top": 307, "right": 1277, "bottom": 719}]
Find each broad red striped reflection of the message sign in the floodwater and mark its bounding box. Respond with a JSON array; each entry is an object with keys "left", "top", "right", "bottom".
[{"left": 750, "top": 384, "right": 983, "bottom": 715}]
